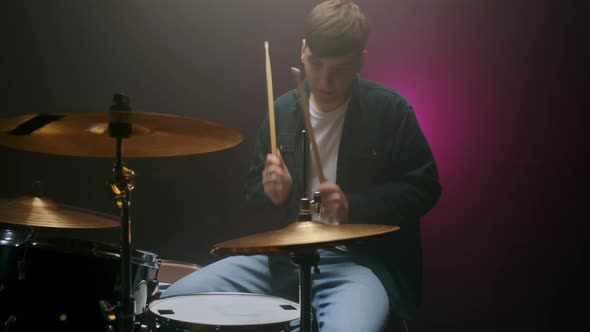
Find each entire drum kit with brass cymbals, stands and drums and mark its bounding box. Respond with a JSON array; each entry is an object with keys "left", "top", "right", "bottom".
[{"left": 0, "top": 94, "right": 399, "bottom": 332}]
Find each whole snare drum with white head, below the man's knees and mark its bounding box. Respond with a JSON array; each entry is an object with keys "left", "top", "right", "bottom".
[{"left": 147, "top": 293, "right": 299, "bottom": 332}]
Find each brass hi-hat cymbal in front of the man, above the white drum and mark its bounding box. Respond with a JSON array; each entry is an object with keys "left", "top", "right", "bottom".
[{"left": 211, "top": 221, "right": 399, "bottom": 255}]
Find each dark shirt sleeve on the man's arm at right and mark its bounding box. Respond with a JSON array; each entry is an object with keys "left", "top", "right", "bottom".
[{"left": 345, "top": 103, "right": 441, "bottom": 225}]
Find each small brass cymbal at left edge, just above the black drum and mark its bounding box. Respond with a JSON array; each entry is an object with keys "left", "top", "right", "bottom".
[{"left": 0, "top": 196, "right": 120, "bottom": 228}]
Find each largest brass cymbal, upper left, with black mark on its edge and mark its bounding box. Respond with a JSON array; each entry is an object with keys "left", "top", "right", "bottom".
[{"left": 0, "top": 111, "right": 242, "bottom": 158}]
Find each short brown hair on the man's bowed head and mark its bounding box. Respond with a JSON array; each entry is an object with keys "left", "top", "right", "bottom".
[{"left": 304, "top": 0, "right": 369, "bottom": 57}]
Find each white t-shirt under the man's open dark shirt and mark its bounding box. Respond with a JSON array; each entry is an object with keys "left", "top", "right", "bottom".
[{"left": 306, "top": 99, "right": 350, "bottom": 224}]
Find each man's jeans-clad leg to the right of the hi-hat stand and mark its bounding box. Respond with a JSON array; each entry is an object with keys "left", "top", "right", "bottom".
[{"left": 312, "top": 250, "right": 396, "bottom": 332}]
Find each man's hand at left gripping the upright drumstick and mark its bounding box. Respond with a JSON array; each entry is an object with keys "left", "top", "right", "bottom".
[{"left": 262, "top": 150, "right": 293, "bottom": 206}]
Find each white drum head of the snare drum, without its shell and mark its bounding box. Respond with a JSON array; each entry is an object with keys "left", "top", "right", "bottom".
[{"left": 149, "top": 293, "right": 299, "bottom": 326}]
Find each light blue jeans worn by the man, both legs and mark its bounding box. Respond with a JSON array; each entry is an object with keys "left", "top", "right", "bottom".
[{"left": 160, "top": 250, "right": 392, "bottom": 332}]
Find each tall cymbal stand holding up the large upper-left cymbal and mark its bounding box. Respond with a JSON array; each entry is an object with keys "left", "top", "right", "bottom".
[{"left": 109, "top": 94, "right": 136, "bottom": 332}]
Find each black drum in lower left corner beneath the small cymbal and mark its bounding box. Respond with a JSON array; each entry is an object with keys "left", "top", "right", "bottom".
[{"left": 0, "top": 231, "right": 158, "bottom": 332}]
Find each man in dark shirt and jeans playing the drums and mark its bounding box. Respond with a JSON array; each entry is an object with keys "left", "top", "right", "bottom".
[{"left": 162, "top": 0, "right": 441, "bottom": 332}]
